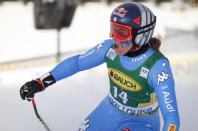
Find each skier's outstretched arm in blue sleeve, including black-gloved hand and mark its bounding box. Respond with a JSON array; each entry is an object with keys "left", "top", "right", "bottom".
[{"left": 20, "top": 40, "right": 112, "bottom": 100}]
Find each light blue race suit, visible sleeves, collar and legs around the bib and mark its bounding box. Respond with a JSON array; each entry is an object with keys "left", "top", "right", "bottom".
[{"left": 50, "top": 39, "right": 180, "bottom": 131}]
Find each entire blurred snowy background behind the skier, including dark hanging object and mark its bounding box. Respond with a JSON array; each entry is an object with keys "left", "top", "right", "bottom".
[{"left": 0, "top": 0, "right": 198, "bottom": 131}]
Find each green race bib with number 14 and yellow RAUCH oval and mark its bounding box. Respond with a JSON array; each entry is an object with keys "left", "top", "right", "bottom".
[{"left": 105, "top": 48, "right": 165, "bottom": 116}]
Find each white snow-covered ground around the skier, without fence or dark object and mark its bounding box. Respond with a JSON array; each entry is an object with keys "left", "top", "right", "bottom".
[{"left": 0, "top": 1, "right": 198, "bottom": 131}]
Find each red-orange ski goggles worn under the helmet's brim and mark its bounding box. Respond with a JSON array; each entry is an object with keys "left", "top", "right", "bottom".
[{"left": 110, "top": 21, "right": 132, "bottom": 42}]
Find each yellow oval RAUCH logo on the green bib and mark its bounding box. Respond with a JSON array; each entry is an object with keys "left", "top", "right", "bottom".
[{"left": 109, "top": 68, "right": 142, "bottom": 92}]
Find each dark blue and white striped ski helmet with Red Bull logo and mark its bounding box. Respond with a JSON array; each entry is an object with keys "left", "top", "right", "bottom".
[{"left": 111, "top": 2, "right": 156, "bottom": 46}]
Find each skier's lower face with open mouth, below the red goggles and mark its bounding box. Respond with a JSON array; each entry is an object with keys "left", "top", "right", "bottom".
[{"left": 113, "top": 38, "right": 132, "bottom": 55}]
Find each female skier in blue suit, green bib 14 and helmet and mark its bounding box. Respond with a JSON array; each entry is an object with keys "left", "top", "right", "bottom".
[{"left": 20, "top": 2, "right": 180, "bottom": 131}]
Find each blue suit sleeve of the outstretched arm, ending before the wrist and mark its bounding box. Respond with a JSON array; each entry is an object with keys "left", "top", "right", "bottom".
[{"left": 50, "top": 40, "right": 112, "bottom": 81}]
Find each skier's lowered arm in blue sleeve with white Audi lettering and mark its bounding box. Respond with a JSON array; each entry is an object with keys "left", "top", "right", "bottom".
[{"left": 149, "top": 59, "right": 180, "bottom": 131}]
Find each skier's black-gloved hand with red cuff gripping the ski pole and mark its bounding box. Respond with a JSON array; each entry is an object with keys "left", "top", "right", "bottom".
[{"left": 20, "top": 79, "right": 44, "bottom": 100}]
